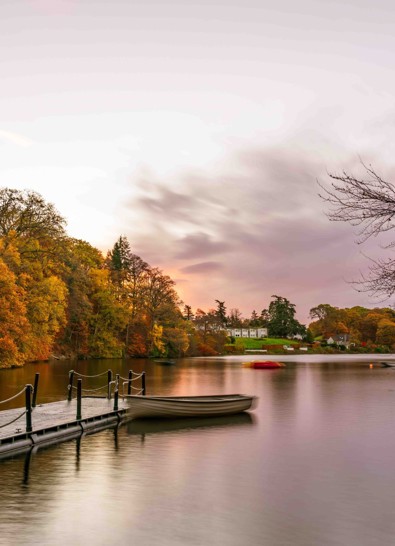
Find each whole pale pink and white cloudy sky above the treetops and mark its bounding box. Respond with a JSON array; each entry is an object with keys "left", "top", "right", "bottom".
[{"left": 0, "top": 0, "right": 395, "bottom": 323}]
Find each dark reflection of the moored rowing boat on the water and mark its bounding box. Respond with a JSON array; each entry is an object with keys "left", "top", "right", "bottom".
[{"left": 126, "top": 413, "right": 256, "bottom": 435}]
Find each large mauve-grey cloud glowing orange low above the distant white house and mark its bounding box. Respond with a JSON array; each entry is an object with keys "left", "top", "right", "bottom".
[{"left": 120, "top": 144, "right": 390, "bottom": 322}]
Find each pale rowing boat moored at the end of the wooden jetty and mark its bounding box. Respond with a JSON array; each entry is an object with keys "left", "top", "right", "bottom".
[{"left": 124, "top": 394, "right": 256, "bottom": 419}]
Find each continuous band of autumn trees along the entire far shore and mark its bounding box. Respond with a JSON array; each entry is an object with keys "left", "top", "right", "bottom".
[{"left": 0, "top": 188, "right": 395, "bottom": 368}]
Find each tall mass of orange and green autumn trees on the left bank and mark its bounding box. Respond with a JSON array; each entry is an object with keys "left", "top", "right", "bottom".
[{"left": 0, "top": 188, "right": 188, "bottom": 367}]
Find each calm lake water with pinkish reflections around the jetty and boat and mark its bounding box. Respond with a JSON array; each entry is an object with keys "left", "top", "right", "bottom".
[{"left": 0, "top": 357, "right": 395, "bottom": 546}]
